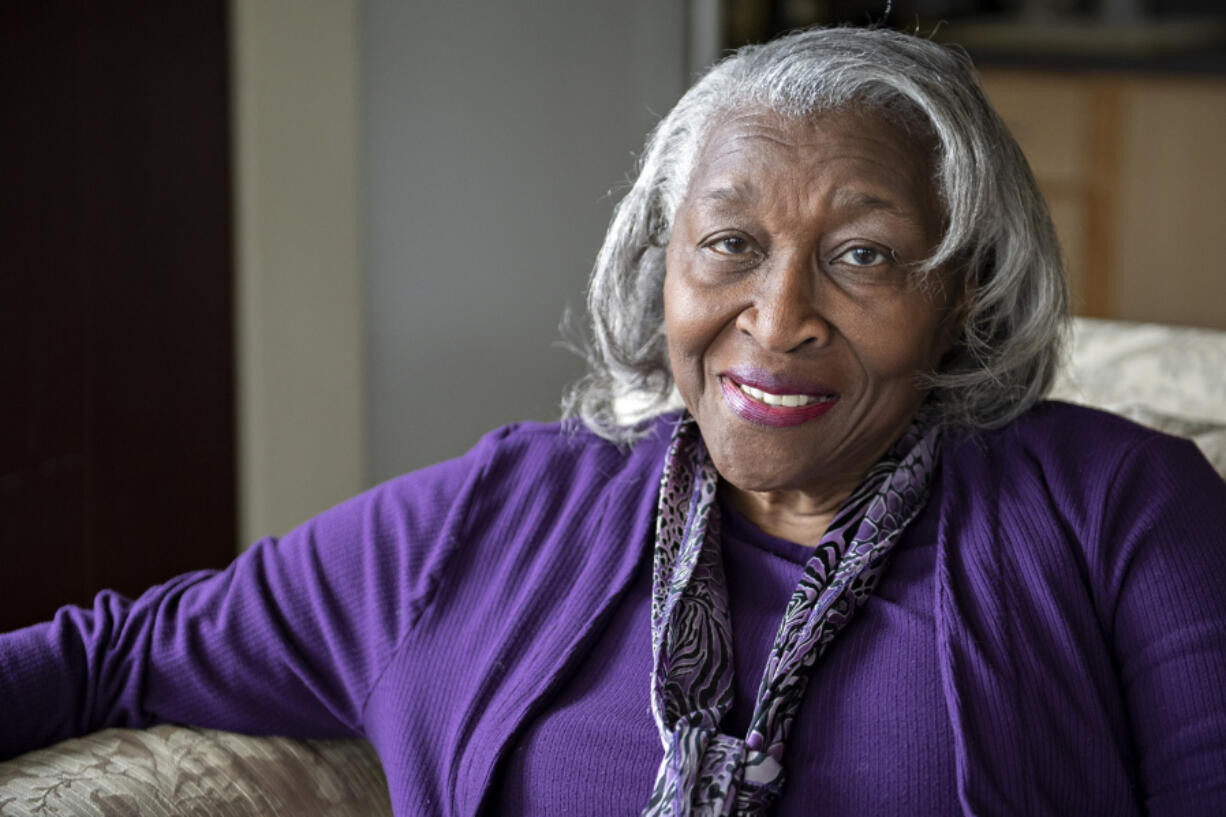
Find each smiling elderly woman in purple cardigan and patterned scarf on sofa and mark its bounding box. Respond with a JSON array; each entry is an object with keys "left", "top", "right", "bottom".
[{"left": 0, "top": 28, "right": 1226, "bottom": 816}]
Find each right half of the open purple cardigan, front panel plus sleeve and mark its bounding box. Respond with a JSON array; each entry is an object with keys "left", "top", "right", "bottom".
[{"left": 937, "top": 404, "right": 1226, "bottom": 817}]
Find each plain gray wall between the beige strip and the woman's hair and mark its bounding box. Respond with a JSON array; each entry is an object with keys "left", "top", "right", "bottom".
[{"left": 359, "top": 0, "right": 689, "bottom": 482}]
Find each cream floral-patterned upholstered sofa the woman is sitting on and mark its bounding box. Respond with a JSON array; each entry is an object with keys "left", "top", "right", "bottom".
[{"left": 0, "top": 319, "right": 1226, "bottom": 817}]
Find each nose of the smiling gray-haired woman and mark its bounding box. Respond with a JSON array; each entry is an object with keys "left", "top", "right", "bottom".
[{"left": 737, "top": 247, "right": 830, "bottom": 352}]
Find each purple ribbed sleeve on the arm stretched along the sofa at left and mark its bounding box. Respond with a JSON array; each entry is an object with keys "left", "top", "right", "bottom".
[{"left": 0, "top": 421, "right": 504, "bottom": 759}]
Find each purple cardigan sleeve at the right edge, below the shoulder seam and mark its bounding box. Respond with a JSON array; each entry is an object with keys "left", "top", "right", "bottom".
[{"left": 1100, "top": 438, "right": 1226, "bottom": 817}]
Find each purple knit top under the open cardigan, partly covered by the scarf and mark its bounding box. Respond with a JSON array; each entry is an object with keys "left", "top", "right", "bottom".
[{"left": 497, "top": 493, "right": 960, "bottom": 817}]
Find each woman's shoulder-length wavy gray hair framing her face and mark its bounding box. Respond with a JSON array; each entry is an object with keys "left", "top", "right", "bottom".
[{"left": 563, "top": 27, "right": 1068, "bottom": 443}]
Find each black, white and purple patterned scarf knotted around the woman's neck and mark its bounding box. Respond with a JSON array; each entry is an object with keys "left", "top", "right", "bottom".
[{"left": 642, "top": 412, "right": 939, "bottom": 817}]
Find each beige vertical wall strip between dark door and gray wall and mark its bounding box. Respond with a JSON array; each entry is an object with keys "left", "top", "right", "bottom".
[{"left": 230, "top": 0, "right": 363, "bottom": 547}]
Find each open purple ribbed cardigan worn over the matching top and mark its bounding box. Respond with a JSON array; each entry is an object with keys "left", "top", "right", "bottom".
[{"left": 0, "top": 404, "right": 1226, "bottom": 816}]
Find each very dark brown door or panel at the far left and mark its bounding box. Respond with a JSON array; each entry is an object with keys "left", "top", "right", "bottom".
[{"left": 0, "top": 0, "right": 235, "bottom": 629}]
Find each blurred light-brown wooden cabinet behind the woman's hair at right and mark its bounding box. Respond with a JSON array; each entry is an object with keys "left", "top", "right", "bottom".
[{"left": 981, "top": 69, "right": 1226, "bottom": 329}]
